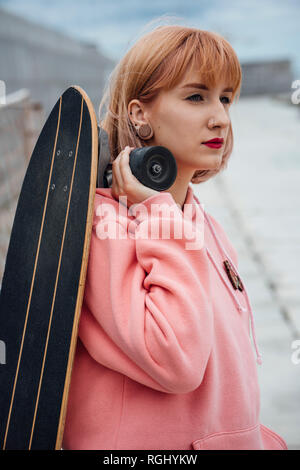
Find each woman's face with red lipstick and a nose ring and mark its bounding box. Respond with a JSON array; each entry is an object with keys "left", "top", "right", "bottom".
[{"left": 133, "top": 67, "right": 233, "bottom": 180}]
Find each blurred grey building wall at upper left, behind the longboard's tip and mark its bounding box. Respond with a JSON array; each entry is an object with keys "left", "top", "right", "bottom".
[{"left": 0, "top": 9, "right": 114, "bottom": 115}]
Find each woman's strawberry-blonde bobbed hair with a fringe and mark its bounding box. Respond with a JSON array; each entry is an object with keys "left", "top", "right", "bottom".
[{"left": 99, "top": 25, "right": 242, "bottom": 184}]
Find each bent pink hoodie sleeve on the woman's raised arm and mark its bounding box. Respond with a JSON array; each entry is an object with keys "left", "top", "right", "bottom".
[{"left": 79, "top": 193, "right": 213, "bottom": 393}]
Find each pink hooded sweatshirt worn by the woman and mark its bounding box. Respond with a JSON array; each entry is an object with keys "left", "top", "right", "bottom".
[{"left": 63, "top": 186, "right": 287, "bottom": 450}]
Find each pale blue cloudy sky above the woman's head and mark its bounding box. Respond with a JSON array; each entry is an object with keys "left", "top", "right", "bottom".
[{"left": 0, "top": 0, "right": 300, "bottom": 78}]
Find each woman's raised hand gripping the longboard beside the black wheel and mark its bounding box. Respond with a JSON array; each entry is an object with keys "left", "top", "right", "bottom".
[{"left": 111, "top": 146, "right": 160, "bottom": 207}]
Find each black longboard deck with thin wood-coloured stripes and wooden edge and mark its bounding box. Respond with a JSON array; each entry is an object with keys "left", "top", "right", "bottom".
[{"left": 0, "top": 86, "right": 98, "bottom": 450}]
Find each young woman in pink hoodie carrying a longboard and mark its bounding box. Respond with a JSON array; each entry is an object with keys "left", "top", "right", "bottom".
[{"left": 63, "top": 25, "right": 287, "bottom": 450}]
